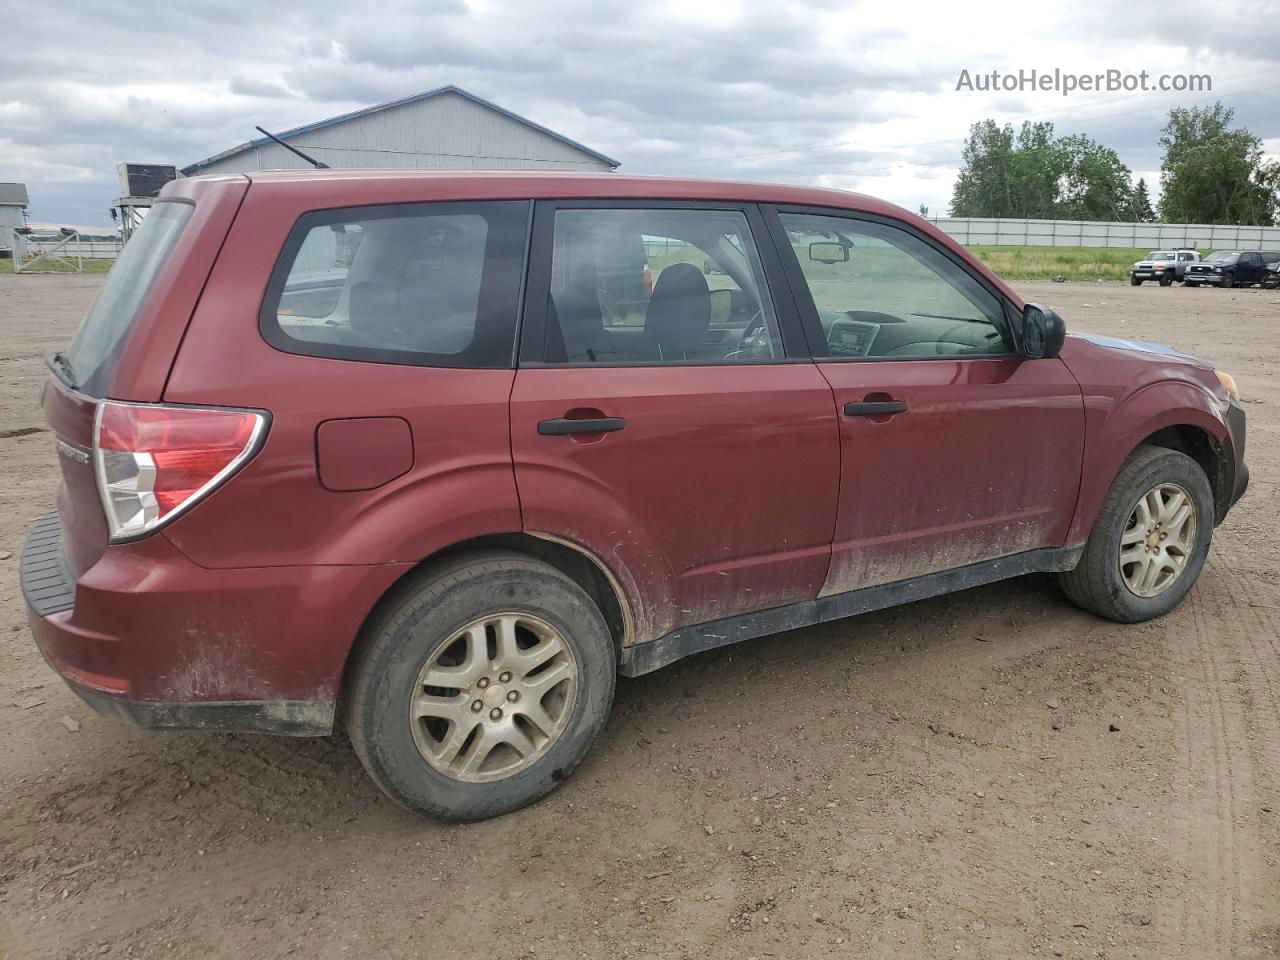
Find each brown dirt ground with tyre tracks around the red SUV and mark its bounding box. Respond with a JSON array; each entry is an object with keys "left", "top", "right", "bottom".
[{"left": 0, "top": 276, "right": 1280, "bottom": 960}]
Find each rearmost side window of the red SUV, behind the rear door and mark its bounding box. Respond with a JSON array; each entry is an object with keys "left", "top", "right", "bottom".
[{"left": 260, "top": 201, "right": 529, "bottom": 367}]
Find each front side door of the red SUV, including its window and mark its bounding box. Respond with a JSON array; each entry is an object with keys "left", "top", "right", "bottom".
[{"left": 768, "top": 209, "right": 1084, "bottom": 596}]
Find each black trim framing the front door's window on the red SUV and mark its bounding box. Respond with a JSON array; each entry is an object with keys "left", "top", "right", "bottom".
[{"left": 762, "top": 204, "right": 1021, "bottom": 364}]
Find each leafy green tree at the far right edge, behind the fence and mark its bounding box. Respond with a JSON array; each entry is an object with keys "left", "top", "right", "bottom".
[{"left": 1160, "top": 102, "right": 1280, "bottom": 227}]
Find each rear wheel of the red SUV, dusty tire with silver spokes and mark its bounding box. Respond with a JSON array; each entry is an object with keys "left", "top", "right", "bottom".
[{"left": 346, "top": 550, "right": 617, "bottom": 820}]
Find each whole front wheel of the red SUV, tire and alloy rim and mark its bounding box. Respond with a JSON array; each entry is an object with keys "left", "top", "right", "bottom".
[{"left": 1060, "top": 447, "right": 1213, "bottom": 623}]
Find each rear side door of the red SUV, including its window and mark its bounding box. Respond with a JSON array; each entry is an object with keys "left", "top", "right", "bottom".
[{"left": 511, "top": 201, "right": 840, "bottom": 641}]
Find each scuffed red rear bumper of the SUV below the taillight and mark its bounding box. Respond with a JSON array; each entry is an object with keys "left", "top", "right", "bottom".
[{"left": 20, "top": 515, "right": 411, "bottom": 735}]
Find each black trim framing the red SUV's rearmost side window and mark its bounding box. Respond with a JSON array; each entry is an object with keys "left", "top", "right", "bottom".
[{"left": 257, "top": 197, "right": 532, "bottom": 370}]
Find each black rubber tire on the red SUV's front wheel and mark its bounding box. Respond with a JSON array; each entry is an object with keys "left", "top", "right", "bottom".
[{"left": 1059, "top": 447, "right": 1213, "bottom": 623}]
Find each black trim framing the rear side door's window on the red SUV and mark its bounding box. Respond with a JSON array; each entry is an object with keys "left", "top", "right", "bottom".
[{"left": 517, "top": 197, "right": 813, "bottom": 370}]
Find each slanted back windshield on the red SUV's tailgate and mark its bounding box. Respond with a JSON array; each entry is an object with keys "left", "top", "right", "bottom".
[{"left": 67, "top": 202, "right": 195, "bottom": 394}]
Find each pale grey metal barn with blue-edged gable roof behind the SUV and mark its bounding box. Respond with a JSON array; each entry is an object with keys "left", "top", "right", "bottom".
[{"left": 182, "top": 86, "right": 618, "bottom": 177}]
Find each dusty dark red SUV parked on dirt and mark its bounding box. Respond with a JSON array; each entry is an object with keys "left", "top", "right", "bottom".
[{"left": 22, "top": 170, "right": 1248, "bottom": 818}]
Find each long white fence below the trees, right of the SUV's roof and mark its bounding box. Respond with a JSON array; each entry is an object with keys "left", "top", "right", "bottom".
[{"left": 929, "top": 216, "right": 1280, "bottom": 250}]
